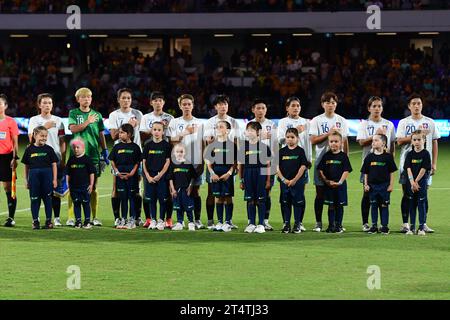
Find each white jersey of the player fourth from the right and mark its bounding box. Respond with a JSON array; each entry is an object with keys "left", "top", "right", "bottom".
[{"left": 278, "top": 117, "right": 312, "bottom": 162}]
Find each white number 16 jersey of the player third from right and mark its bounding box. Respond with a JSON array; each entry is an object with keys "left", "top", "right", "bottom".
[{"left": 309, "top": 113, "right": 348, "bottom": 162}]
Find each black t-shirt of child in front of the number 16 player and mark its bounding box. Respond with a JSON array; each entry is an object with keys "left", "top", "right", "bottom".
[{"left": 317, "top": 150, "right": 352, "bottom": 182}]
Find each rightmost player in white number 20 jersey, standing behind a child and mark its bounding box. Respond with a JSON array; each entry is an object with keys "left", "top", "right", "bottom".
[{"left": 397, "top": 94, "right": 440, "bottom": 233}]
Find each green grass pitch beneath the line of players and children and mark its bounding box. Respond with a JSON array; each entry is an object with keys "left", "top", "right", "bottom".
[{"left": 0, "top": 138, "right": 450, "bottom": 300}]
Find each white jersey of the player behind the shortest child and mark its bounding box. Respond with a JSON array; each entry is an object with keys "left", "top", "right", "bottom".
[{"left": 169, "top": 116, "right": 203, "bottom": 164}]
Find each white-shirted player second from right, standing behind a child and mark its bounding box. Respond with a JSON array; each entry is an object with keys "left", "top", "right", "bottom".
[{"left": 356, "top": 97, "right": 395, "bottom": 232}]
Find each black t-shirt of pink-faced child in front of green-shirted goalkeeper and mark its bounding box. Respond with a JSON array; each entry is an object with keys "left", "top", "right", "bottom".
[{"left": 66, "top": 154, "right": 97, "bottom": 188}]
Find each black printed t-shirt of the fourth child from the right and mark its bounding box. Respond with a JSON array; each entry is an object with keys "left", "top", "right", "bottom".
[{"left": 278, "top": 146, "right": 308, "bottom": 180}]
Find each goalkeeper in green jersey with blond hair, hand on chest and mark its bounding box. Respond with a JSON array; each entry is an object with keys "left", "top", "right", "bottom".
[{"left": 66, "top": 88, "right": 109, "bottom": 226}]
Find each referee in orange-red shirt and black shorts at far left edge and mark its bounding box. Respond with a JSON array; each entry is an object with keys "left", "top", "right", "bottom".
[{"left": 0, "top": 94, "right": 19, "bottom": 227}]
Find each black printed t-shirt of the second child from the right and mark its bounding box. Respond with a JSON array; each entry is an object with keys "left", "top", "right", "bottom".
[{"left": 361, "top": 152, "right": 397, "bottom": 184}]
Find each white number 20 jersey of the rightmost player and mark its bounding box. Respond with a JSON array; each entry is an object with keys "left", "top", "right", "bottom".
[{"left": 396, "top": 116, "right": 441, "bottom": 172}]
